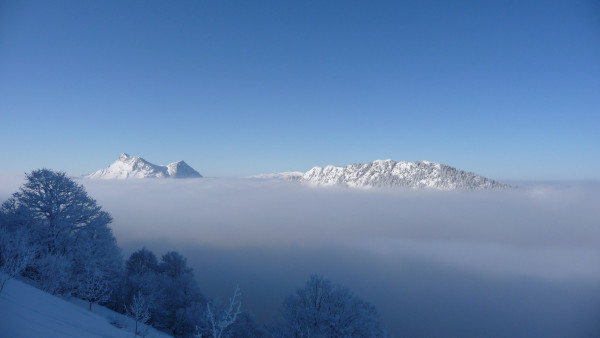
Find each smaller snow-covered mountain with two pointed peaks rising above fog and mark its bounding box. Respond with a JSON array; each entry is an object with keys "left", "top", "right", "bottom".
[{"left": 85, "top": 154, "right": 202, "bottom": 179}]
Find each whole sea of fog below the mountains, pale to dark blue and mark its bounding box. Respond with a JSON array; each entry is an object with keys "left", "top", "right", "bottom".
[{"left": 0, "top": 178, "right": 600, "bottom": 337}]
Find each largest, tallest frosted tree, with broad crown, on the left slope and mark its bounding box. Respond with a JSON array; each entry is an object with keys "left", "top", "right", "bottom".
[{"left": 0, "top": 169, "right": 122, "bottom": 294}]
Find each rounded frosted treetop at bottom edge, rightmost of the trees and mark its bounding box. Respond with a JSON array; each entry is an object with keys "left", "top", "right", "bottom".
[{"left": 275, "top": 275, "right": 383, "bottom": 337}]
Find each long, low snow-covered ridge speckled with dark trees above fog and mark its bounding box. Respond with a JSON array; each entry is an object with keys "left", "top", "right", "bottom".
[{"left": 270, "top": 160, "right": 510, "bottom": 190}]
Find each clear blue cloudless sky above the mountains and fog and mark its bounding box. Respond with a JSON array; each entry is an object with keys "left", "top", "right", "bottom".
[{"left": 0, "top": 0, "right": 600, "bottom": 179}]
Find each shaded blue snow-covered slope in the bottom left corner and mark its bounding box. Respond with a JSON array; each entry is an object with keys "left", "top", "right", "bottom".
[{"left": 0, "top": 279, "right": 169, "bottom": 338}]
